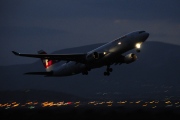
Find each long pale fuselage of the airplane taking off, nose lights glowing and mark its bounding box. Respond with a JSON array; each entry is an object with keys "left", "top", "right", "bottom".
[{"left": 53, "top": 31, "right": 149, "bottom": 76}]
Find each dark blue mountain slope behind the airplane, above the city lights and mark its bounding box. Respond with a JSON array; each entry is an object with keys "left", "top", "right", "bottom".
[{"left": 0, "top": 41, "right": 180, "bottom": 99}]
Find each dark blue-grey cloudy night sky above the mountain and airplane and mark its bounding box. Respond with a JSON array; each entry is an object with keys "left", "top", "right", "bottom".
[{"left": 0, "top": 0, "right": 180, "bottom": 65}]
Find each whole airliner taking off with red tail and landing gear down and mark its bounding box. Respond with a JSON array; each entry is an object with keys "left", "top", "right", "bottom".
[{"left": 12, "top": 30, "right": 149, "bottom": 77}]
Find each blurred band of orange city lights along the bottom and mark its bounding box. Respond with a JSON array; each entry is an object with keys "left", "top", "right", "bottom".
[{"left": 0, "top": 100, "right": 180, "bottom": 109}]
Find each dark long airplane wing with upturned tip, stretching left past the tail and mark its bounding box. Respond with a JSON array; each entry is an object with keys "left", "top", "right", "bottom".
[{"left": 12, "top": 51, "right": 86, "bottom": 63}]
